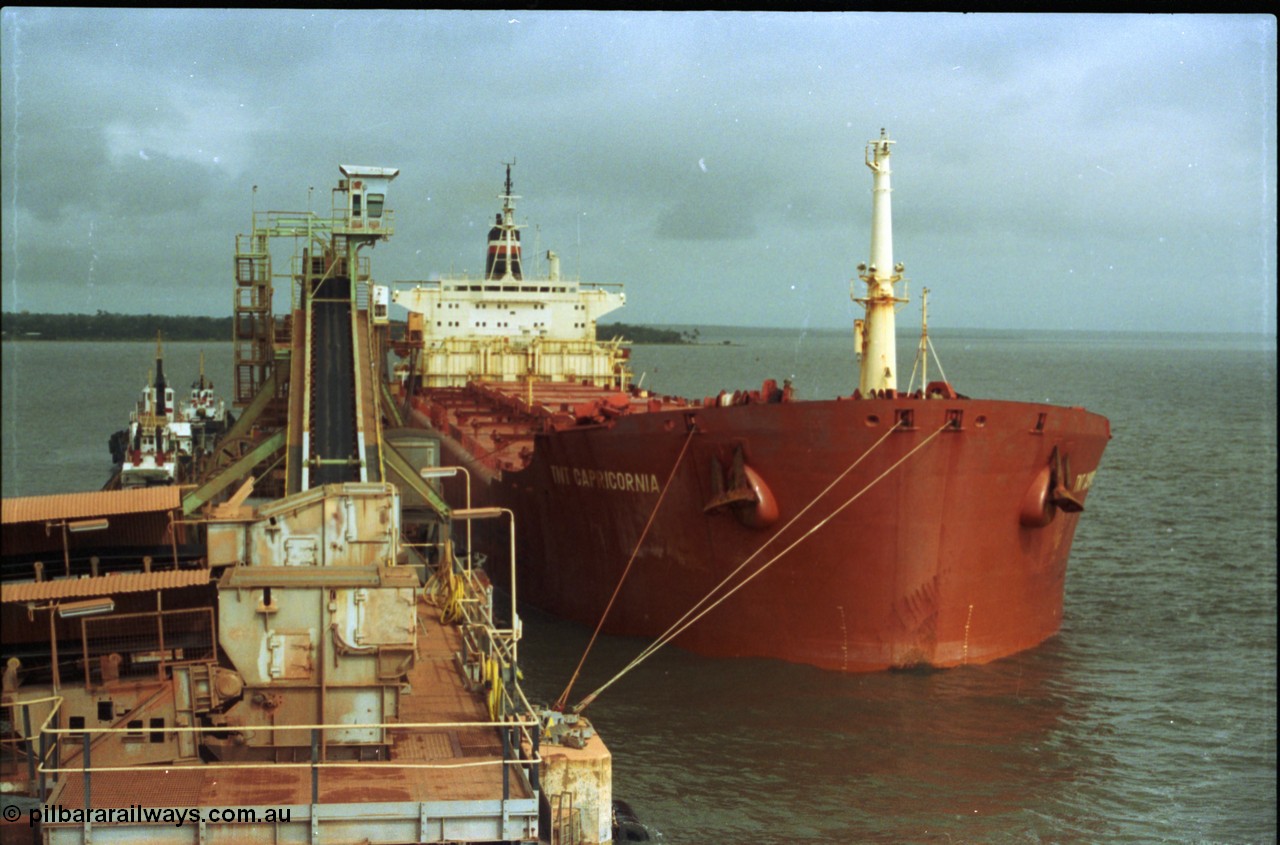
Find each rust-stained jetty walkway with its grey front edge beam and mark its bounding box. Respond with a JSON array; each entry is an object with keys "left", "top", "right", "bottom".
[{"left": 32, "top": 603, "right": 538, "bottom": 845}]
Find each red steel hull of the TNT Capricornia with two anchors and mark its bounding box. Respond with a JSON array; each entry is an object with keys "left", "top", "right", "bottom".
[{"left": 415, "top": 385, "right": 1110, "bottom": 672}]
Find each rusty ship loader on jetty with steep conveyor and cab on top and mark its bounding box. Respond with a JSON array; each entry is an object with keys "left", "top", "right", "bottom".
[{"left": 0, "top": 165, "right": 613, "bottom": 845}]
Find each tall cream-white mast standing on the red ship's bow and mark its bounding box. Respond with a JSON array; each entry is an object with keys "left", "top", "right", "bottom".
[{"left": 854, "top": 129, "right": 906, "bottom": 397}]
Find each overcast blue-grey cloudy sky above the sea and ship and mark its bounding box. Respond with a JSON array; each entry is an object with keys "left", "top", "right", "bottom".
[{"left": 0, "top": 6, "right": 1276, "bottom": 333}]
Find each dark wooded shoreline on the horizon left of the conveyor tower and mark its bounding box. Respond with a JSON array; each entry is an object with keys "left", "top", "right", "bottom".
[{"left": 0, "top": 311, "right": 232, "bottom": 341}]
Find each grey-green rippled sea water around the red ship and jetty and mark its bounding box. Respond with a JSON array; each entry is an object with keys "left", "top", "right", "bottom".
[{"left": 0, "top": 328, "right": 1276, "bottom": 844}]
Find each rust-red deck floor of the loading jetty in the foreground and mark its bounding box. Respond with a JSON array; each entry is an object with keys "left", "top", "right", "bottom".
[{"left": 46, "top": 603, "right": 538, "bottom": 845}]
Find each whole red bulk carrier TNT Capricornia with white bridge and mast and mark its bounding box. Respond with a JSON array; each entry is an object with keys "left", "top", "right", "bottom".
[{"left": 393, "top": 132, "right": 1110, "bottom": 672}]
